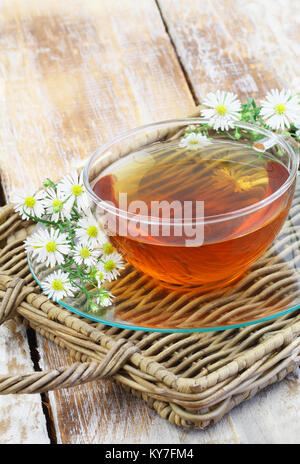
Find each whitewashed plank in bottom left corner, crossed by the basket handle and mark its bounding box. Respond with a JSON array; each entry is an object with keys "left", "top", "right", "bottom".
[{"left": 0, "top": 321, "right": 50, "bottom": 444}]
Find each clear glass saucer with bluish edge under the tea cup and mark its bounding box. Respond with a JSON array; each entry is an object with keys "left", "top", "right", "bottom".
[{"left": 28, "top": 181, "right": 300, "bottom": 333}]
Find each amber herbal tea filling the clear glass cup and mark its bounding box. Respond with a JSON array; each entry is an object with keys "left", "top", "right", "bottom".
[{"left": 94, "top": 140, "right": 293, "bottom": 288}]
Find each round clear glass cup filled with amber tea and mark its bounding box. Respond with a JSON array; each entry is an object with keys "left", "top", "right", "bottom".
[{"left": 83, "top": 118, "right": 298, "bottom": 291}]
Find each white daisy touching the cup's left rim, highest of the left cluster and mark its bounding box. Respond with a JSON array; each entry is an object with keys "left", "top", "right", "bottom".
[{"left": 57, "top": 171, "right": 91, "bottom": 211}]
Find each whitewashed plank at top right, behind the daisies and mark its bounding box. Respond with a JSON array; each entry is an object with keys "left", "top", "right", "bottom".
[{"left": 158, "top": 0, "right": 300, "bottom": 102}]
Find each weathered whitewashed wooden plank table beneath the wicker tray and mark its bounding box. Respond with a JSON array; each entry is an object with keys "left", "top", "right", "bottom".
[{"left": 0, "top": 0, "right": 300, "bottom": 444}]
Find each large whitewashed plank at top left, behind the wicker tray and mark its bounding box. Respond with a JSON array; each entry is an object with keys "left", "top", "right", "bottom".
[{"left": 0, "top": 0, "right": 194, "bottom": 197}]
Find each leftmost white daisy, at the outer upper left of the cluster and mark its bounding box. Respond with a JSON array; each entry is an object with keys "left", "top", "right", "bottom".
[{"left": 12, "top": 190, "right": 45, "bottom": 220}]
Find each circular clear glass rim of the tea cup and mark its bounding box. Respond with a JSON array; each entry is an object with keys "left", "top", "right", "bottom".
[{"left": 83, "top": 117, "right": 299, "bottom": 226}]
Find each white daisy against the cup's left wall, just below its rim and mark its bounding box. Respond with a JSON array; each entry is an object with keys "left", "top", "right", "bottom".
[{"left": 75, "top": 212, "right": 107, "bottom": 248}]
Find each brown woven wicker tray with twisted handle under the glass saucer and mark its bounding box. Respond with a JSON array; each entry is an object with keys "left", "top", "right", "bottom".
[{"left": 0, "top": 111, "right": 300, "bottom": 428}]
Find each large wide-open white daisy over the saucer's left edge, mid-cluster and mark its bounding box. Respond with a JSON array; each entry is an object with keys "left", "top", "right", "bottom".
[{"left": 25, "top": 228, "right": 71, "bottom": 267}]
